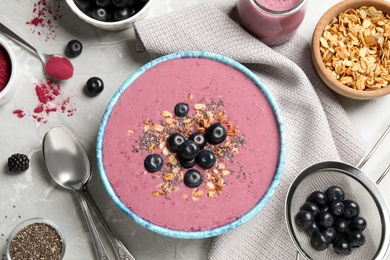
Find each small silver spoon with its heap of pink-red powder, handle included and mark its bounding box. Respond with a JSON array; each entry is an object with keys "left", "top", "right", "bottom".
[{"left": 0, "top": 23, "right": 73, "bottom": 80}]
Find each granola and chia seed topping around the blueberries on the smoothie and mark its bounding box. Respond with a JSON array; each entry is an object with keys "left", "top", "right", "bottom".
[{"left": 127, "top": 94, "right": 245, "bottom": 201}]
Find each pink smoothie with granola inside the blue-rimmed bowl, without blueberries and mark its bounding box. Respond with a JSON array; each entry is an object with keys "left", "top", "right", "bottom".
[{"left": 102, "top": 58, "right": 280, "bottom": 231}]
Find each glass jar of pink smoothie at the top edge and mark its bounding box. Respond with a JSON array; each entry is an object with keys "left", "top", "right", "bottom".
[{"left": 237, "top": 0, "right": 307, "bottom": 46}]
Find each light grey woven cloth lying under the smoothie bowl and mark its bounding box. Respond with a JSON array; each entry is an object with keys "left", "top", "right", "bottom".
[{"left": 134, "top": 2, "right": 364, "bottom": 259}]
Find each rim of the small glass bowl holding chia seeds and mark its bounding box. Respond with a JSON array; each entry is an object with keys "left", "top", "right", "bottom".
[{"left": 5, "top": 217, "right": 66, "bottom": 260}]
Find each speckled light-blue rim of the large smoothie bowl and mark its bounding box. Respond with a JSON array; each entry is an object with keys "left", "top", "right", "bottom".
[{"left": 96, "top": 51, "right": 286, "bottom": 239}]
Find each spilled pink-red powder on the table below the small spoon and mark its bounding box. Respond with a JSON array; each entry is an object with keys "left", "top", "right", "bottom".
[{"left": 13, "top": 80, "right": 76, "bottom": 123}]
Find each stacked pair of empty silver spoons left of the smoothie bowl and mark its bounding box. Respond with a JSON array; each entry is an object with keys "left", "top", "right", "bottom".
[{"left": 43, "top": 127, "right": 135, "bottom": 260}]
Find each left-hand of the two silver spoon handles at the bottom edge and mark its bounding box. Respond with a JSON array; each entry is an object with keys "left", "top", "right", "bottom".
[{"left": 75, "top": 189, "right": 109, "bottom": 260}]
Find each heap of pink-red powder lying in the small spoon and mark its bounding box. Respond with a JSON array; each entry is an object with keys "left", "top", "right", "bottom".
[{"left": 45, "top": 56, "right": 73, "bottom": 80}]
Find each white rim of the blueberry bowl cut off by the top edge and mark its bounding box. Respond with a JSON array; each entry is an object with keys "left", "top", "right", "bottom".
[{"left": 66, "top": 0, "right": 155, "bottom": 28}]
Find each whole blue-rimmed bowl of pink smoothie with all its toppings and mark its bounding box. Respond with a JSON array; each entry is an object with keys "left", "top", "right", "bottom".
[{"left": 97, "top": 52, "right": 285, "bottom": 239}]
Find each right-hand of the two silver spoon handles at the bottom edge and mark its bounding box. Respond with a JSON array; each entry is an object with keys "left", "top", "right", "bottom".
[{"left": 84, "top": 188, "right": 135, "bottom": 260}]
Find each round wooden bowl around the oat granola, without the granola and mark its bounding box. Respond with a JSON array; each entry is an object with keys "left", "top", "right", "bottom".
[{"left": 312, "top": 0, "right": 390, "bottom": 100}]
